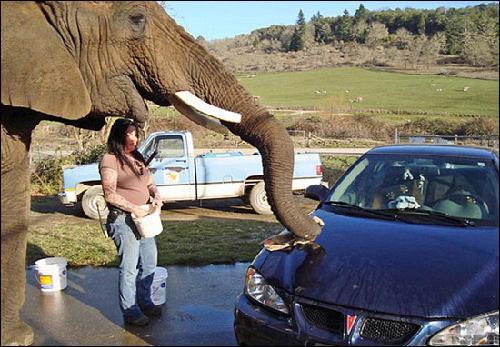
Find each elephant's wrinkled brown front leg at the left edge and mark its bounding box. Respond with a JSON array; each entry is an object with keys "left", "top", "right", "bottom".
[{"left": 1, "top": 109, "right": 37, "bottom": 346}]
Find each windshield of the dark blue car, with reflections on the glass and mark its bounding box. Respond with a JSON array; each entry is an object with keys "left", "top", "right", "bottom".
[{"left": 327, "top": 154, "right": 499, "bottom": 226}]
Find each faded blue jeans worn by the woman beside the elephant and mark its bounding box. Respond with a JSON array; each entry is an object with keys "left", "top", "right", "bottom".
[{"left": 108, "top": 215, "right": 157, "bottom": 319}]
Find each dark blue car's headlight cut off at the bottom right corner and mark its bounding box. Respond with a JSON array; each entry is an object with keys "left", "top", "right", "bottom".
[{"left": 429, "top": 311, "right": 499, "bottom": 346}]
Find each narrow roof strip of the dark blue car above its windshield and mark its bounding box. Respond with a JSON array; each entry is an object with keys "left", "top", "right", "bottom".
[{"left": 366, "top": 144, "right": 497, "bottom": 160}]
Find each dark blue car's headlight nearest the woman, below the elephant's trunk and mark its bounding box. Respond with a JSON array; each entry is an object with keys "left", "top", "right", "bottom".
[{"left": 245, "top": 267, "right": 289, "bottom": 314}]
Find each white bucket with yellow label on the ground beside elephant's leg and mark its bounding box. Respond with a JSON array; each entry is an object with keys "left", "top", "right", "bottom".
[{"left": 35, "top": 257, "right": 68, "bottom": 292}]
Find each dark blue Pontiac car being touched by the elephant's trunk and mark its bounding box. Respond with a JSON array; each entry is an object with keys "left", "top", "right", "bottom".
[{"left": 234, "top": 145, "right": 499, "bottom": 346}]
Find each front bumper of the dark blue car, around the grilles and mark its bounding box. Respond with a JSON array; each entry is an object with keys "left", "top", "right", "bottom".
[{"left": 234, "top": 294, "right": 456, "bottom": 346}]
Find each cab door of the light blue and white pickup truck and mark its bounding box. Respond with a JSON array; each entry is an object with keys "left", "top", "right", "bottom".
[{"left": 144, "top": 134, "right": 195, "bottom": 201}]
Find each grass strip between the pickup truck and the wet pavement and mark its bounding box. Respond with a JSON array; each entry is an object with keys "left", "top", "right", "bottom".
[{"left": 26, "top": 219, "right": 282, "bottom": 267}]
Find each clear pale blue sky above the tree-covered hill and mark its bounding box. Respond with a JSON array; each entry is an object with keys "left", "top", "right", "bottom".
[{"left": 163, "top": 1, "right": 492, "bottom": 40}]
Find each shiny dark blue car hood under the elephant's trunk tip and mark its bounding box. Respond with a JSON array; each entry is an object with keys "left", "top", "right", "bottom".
[{"left": 260, "top": 209, "right": 499, "bottom": 318}]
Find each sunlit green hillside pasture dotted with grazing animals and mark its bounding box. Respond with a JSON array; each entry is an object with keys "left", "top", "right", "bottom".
[{"left": 238, "top": 67, "right": 499, "bottom": 117}]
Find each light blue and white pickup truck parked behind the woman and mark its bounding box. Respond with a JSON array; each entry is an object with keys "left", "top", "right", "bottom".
[{"left": 59, "top": 131, "right": 323, "bottom": 219}]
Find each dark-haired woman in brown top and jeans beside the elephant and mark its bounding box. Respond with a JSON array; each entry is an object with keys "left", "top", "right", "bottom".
[{"left": 99, "top": 118, "right": 162, "bottom": 325}]
